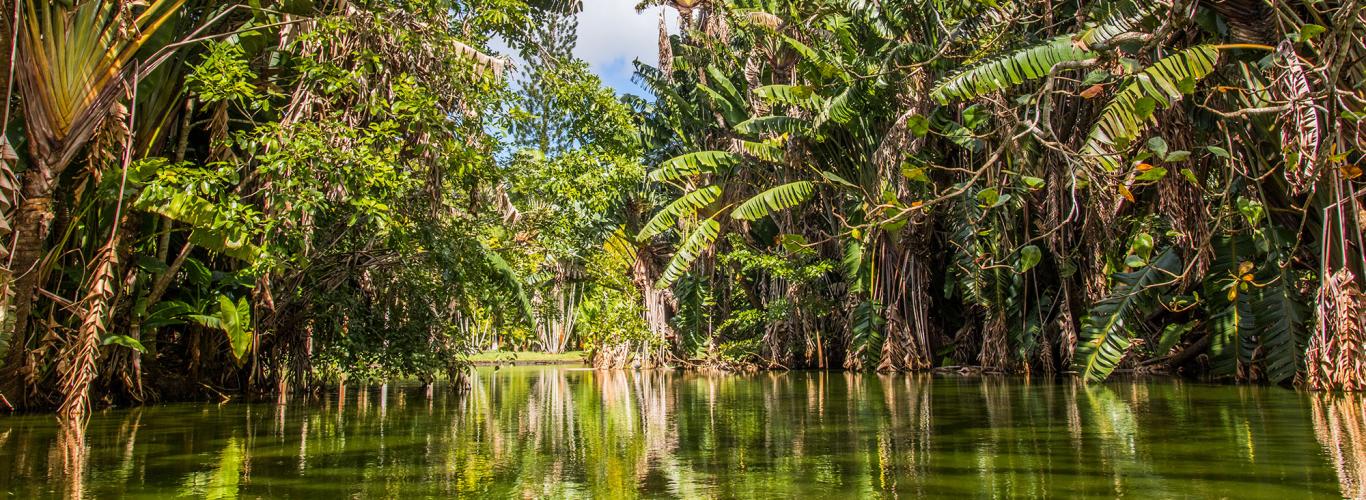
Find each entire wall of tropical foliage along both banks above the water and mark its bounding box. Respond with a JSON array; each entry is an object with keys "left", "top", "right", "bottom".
[{"left": 0, "top": 0, "right": 1366, "bottom": 414}]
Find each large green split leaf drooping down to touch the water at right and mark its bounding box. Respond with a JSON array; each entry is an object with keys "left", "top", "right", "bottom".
[{"left": 1075, "top": 250, "right": 1182, "bottom": 383}]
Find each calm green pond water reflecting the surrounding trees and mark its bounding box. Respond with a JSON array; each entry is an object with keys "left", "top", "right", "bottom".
[{"left": 0, "top": 366, "right": 1366, "bottom": 499}]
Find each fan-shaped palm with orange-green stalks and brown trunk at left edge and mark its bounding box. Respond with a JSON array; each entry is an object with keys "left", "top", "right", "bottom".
[{"left": 5, "top": 0, "right": 184, "bottom": 398}]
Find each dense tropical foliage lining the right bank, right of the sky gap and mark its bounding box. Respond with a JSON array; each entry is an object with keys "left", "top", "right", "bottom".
[{"left": 631, "top": 0, "right": 1366, "bottom": 389}]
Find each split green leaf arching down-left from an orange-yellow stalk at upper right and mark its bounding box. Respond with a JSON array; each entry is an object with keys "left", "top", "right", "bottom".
[{"left": 1082, "top": 45, "right": 1218, "bottom": 171}]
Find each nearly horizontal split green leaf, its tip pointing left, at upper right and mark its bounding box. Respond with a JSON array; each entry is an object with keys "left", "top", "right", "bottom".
[{"left": 930, "top": 36, "right": 1096, "bottom": 104}]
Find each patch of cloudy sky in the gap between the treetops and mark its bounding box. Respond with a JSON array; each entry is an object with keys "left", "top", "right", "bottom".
[{"left": 574, "top": 0, "right": 678, "bottom": 94}]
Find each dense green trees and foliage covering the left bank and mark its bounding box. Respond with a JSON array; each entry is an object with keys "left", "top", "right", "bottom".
[{"left": 0, "top": 0, "right": 643, "bottom": 414}]
